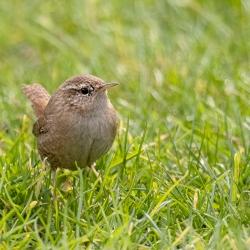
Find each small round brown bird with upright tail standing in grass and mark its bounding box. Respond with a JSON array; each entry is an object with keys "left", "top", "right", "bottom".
[{"left": 22, "top": 74, "right": 118, "bottom": 184}]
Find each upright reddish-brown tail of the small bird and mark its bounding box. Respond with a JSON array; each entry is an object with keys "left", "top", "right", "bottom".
[{"left": 22, "top": 83, "right": 50, "bottom": 117}]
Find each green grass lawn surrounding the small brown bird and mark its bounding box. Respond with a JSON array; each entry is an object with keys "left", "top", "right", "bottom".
[{"left": 0, "top": 0, "right": 250, "bottom": 250}]
